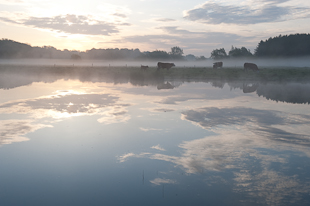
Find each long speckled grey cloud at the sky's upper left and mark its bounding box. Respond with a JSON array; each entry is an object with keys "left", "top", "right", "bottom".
[{"left": 0, "top": 14, "right": 130, "bottom": 36}]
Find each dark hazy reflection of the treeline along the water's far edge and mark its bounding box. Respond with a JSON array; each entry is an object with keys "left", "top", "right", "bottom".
[{"left": 0, "top": 66, "right": 310, "bottom": 104}]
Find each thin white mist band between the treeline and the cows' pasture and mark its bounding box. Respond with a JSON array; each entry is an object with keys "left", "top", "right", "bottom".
[{"left": 0, "top": 56, "right": 310, "bottom": 68}]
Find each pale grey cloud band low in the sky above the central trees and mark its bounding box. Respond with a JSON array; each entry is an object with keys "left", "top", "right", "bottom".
[{"left": 116, "top": 26, "right": 252, "bottom": 55}]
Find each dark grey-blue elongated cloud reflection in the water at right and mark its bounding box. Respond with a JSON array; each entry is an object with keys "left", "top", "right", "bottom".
[{"left": 182, "top": 107, "right": 310, "bottom": 146}]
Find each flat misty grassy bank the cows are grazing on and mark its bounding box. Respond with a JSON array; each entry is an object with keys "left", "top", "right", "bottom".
[{"left": 0, "top": 65, "right": 310, "bottom": 82}]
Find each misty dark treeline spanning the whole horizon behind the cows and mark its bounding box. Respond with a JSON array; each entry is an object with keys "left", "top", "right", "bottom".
[{"left": 0, "top": 34, "right": 310, "bottom": 61}]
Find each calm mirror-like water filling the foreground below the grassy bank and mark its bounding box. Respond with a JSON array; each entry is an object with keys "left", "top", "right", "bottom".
[{"left": 0, "top": 67, "right": 310, "bottom": 206}]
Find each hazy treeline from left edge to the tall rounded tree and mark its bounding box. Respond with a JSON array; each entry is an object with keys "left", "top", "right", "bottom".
[{"left": 0, "top": 39, "right": 183, "bottom": 60}]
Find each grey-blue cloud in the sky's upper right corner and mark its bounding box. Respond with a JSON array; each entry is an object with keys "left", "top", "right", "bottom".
[{"left": 184, "top": 0, "right": 310, "bottom": 25}]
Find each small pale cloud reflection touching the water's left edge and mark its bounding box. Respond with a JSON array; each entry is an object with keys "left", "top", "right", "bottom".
[{"left": 0, "top": 120, "right": 51, "bottom": 145}]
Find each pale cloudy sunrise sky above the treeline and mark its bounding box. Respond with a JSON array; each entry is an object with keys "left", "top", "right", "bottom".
[{"left": 0, "top": 0, "right": 310, "bottom": 57}]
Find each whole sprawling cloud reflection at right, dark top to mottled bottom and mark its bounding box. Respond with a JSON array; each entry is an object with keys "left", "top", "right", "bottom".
[{"left": 118, "top": 107, "right": 310, "bottom": 205}]
